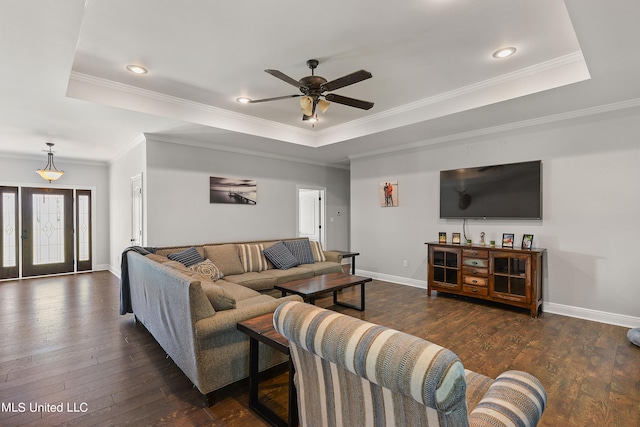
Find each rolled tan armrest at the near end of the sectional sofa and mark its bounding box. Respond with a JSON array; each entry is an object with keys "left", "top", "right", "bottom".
[{"left": 195, "top": 295, "right": 302, "bottom": 339}]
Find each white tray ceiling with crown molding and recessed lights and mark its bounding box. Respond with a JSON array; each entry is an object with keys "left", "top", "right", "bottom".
[{"left": 0, "top": 0, "right": 640, "bottom": 165}]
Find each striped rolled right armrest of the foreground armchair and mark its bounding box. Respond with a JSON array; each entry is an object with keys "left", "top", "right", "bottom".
[{"left": 469, "top": 371, "right": 547, "bottom": 427}]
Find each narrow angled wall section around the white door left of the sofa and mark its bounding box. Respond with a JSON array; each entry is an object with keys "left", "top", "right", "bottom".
[{"left": 109, "top": 140, "right": 147, "bottom": 274}]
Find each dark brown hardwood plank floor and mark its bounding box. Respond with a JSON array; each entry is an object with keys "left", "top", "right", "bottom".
[{"left": 0, "top": 272, "right": 640, "bottom": 427}]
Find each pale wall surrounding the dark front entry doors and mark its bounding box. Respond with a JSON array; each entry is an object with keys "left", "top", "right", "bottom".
[{"left": 0, "top": 153, "right": 110, "bottom": 269}]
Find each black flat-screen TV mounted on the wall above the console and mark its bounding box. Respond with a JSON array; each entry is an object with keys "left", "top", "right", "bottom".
[{"left": 440, "top": 160, "right": 542, "bottom": 219}]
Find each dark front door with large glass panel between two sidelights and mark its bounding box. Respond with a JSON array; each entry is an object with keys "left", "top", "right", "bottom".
[{"left": 22, "top": 188, "right": 74, "bottom": 277}]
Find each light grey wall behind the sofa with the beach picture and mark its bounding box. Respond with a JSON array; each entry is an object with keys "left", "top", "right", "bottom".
[{"left": 147, "top": 140, "right": 349, "bottom": 249}]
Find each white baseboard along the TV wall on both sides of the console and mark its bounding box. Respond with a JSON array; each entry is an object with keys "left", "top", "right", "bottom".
[{"left": 356, "top": 269, "right": 640, "bottom": 328}]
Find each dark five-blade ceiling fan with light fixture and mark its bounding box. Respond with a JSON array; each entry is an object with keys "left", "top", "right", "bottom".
[{"left": 238, "top": 59, "right": 373, "bottom": 122}]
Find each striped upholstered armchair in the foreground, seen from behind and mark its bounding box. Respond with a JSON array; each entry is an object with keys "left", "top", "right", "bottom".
[{"left": 274, "top": 302, "right": 546, "bottom": 427}]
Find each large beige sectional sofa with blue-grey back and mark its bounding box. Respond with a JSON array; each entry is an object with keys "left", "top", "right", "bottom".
[{"left": 120, "top": 239, "right": 342, "bottom": 403}]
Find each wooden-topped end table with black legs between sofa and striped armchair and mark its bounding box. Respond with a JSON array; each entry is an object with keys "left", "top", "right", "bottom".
[{"left": 237, "top": 313, "right": 298, "bottom": 427}]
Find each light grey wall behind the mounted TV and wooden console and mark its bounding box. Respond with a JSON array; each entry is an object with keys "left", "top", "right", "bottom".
[{"left": 351, "top": 110, "right": 640, "bottom": 326}]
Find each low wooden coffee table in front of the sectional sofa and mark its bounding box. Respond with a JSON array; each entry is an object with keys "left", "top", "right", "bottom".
[{"left": 274, "top": 273, "right": 371, "bottom": 311}]
